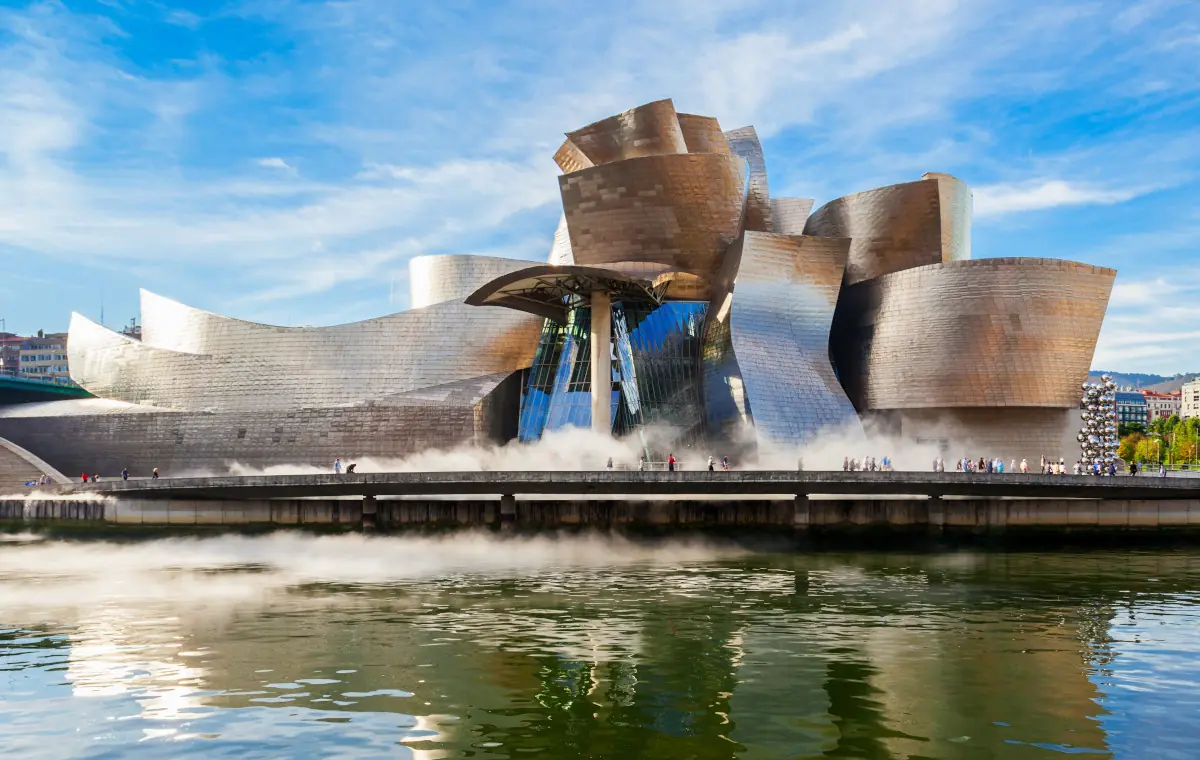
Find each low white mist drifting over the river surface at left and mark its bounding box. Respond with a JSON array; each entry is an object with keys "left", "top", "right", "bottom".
[{"left": 0, "top": 531, "right": 740, "bottom": 622}]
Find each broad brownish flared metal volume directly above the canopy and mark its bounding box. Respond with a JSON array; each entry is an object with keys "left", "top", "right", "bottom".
[{"left": 558, "top": 154, "right": 744, "bottom": 276}]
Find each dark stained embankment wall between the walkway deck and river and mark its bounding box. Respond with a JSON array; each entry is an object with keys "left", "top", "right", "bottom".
[{"left": 0, "top": 497, "right": 1200, "bottom": 532}]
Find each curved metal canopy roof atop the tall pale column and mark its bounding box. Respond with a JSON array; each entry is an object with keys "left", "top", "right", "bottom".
[{"left": 466, "top": 264, "right": 670, "bottom": 323}]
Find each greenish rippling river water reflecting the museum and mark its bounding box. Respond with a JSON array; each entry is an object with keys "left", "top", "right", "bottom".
[{"left": 0, "top": 533, "right": 1200, "bottom": 759}]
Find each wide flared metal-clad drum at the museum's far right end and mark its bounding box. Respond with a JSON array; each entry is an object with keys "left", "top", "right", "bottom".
[{"left": 832, "top": 258, "right": 1116, "bottom": 412}]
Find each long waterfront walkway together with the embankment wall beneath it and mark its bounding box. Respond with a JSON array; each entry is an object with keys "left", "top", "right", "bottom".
[{"left": 0, "top": 471, "right": 1200, "bottom": 532}]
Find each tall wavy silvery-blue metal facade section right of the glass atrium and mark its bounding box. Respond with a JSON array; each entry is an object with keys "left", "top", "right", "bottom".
[{"left": 700, "top": 232, "right": 860, "bottom": 444}]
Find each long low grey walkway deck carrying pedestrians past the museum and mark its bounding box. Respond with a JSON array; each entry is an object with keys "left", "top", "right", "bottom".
[{"left": 41, "top": 471, "right": 1200, "bottom": 501}]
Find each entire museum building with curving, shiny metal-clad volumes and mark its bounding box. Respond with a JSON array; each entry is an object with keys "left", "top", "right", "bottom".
[{"left": 0, "top": 100, "right": 1116, "bottom": 473}]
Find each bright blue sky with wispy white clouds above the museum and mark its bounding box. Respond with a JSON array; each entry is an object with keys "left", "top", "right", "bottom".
[{"left": 0, "top": 0, "right": 1200, "bottom": 373}]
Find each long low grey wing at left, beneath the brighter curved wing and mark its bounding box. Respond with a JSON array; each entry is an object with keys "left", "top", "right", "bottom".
[{"left": 0, "top": 373, "right": 520, "bottom": 478}]
